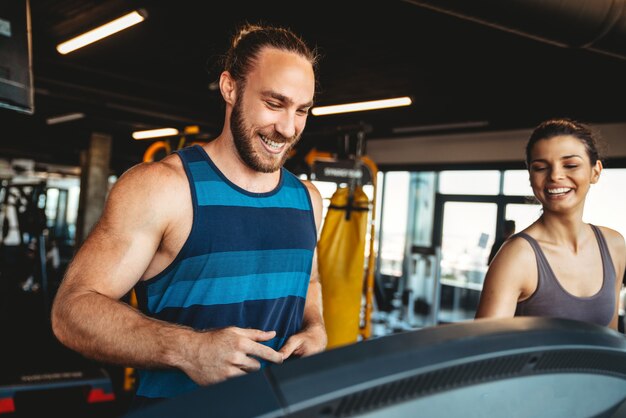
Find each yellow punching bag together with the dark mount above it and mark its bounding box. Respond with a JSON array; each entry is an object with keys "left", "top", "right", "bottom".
[{"left": 305, "top": 125, "right": 378, "bottom": 348}]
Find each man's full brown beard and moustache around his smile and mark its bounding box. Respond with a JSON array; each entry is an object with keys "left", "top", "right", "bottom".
[{"left": 230, "top": 100, "right": 300, "bottom": 173}]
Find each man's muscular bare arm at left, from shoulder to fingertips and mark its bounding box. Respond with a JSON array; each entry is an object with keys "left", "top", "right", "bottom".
[{"left": 52, "top": 157, "right": 282, "bottom": 384}]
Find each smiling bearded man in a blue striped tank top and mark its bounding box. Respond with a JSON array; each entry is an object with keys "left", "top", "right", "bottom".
[{"left": 52, "top": 25, "right": 326, "bottom": 406}]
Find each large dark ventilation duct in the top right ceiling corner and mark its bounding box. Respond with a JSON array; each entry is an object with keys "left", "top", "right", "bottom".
[{"left": 404, "top": 0, "right": 626, "bottom": 59}]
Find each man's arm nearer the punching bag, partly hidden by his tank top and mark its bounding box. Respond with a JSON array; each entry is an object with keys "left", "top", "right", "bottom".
[{"left": 280, "top": 181, "right": 328, "bottom": 359}]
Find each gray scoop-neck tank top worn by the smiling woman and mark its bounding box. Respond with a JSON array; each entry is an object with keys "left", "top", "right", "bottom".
[{"left": 515, "top": 225, "right": 615, "bottom": 326}]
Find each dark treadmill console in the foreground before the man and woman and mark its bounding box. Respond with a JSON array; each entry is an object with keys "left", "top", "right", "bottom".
[{"left": 120, "top": 317, "right": 626, "bottom": 418}]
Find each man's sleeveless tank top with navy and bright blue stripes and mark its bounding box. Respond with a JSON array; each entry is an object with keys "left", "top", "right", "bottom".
[{"left": 135, "top": 145, "right": 317, "bottom": 404}]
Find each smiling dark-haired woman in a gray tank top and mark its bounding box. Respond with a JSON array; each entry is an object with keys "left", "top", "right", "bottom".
[{"left": 476, "top": 119, "right": 626, "bottom": 329}]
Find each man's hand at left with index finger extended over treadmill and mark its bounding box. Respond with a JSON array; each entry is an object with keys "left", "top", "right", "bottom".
[{"left": 182, "top": 327, "right": 283, "bottom": 385}]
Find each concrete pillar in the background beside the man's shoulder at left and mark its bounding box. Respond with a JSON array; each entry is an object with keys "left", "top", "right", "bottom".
[{"left": 76, "top": 132, "right": 112, "bottom": 248}]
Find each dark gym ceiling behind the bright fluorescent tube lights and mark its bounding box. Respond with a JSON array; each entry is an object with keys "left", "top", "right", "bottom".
[{"left": 0, "top": 0, "right": 626, "bottom": 175}]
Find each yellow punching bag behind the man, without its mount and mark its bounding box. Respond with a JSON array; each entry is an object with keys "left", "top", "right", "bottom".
[{"left": 317, "top": 186, "right": 369, "bottom": 348}]
